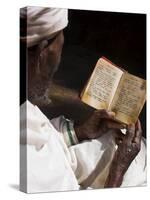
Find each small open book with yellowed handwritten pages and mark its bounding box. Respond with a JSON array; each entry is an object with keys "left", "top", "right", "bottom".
[{"left": 81, "top": 57, "right": 146, "bottom": 124}]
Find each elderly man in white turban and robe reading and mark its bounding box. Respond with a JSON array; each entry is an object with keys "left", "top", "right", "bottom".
[{"left": 20, "top": 7, "right": 146, "bottom": 193}]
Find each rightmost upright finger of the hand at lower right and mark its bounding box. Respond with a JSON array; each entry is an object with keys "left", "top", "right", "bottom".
[{"left": 132, "top": 119, "right": 142, "bottom": 144}]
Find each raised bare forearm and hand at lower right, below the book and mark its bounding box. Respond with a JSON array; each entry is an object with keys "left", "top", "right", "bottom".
[{"left": 105, "top": 120, "right": 142, "bottom": 187}]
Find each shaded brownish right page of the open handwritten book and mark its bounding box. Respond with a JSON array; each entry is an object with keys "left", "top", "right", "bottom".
[{"left": 110, "top": 73, "right": 146, "bottom": 124}]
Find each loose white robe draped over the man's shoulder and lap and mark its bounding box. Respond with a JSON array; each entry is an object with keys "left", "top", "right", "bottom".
[{"left": 21, "top": 101, "right": 146, "bottom": 193}]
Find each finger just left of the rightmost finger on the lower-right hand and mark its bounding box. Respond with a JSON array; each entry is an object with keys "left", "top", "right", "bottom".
[{"left": 125, "top": 124, "right": 135, "bottom": 144}]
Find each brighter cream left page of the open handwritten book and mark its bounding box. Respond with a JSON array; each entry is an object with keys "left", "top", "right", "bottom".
[{"left": 81, "top": 57, "right": 123, "bottom": 109}]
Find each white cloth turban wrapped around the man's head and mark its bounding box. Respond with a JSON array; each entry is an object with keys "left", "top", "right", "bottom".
[{"left": 20, "top": 6, "right": 68, "bottom": 47}]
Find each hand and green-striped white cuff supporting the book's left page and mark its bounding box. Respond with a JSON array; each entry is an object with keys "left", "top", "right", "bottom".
[{"left": 51, "top": 110, "right": 124, "bottom": 147}]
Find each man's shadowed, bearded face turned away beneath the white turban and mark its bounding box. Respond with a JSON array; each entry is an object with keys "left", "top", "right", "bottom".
[{"left": 28, "top": 31, "right": 64, "bottom": 105}]
